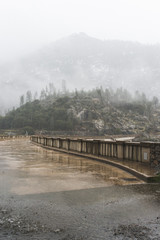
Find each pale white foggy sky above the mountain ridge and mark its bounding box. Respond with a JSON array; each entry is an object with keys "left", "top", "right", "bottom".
[{"left": 0, "top": 0, "right": 160, "bottom": 63}]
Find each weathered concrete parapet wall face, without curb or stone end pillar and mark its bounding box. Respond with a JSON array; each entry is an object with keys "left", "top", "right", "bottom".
[{"left": 31, "top": 136, "right": 153, "bottom": 163}]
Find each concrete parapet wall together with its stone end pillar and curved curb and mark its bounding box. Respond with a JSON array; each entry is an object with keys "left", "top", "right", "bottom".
[{"left": 31, "top": 136, "right": 160, "bottom": 181}]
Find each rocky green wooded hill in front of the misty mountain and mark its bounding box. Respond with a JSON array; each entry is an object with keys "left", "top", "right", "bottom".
[{"left": 0, "top": 87, "right": 160, "bottom": 139}]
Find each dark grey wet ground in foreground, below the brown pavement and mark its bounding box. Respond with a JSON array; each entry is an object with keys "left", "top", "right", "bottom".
[{"left": 0, "top": 184, "right": 160, "bottom": 240}]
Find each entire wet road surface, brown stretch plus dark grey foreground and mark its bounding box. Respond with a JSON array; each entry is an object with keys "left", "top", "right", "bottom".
[{"left": 0, "top": 140, "right": 160, "bottom": 240}]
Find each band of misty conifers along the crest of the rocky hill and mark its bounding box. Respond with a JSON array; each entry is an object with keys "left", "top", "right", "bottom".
[{"left": 20, "top": 80, "right": 159, "bottom": 106}]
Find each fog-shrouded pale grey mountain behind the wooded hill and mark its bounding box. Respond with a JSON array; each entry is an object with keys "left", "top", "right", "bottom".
[{"left": 0, "top": 33, "right": 160, "bottom": 111}]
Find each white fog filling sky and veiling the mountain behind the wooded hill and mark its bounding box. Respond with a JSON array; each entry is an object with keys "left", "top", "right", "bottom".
[{"left": 0, "top": 0, "right": 160, "bottom": 114}]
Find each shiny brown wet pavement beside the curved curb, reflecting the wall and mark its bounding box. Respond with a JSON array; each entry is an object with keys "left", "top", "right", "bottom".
[{"left": 0, "top": 140, "right": 142, "bottom": 194}]
